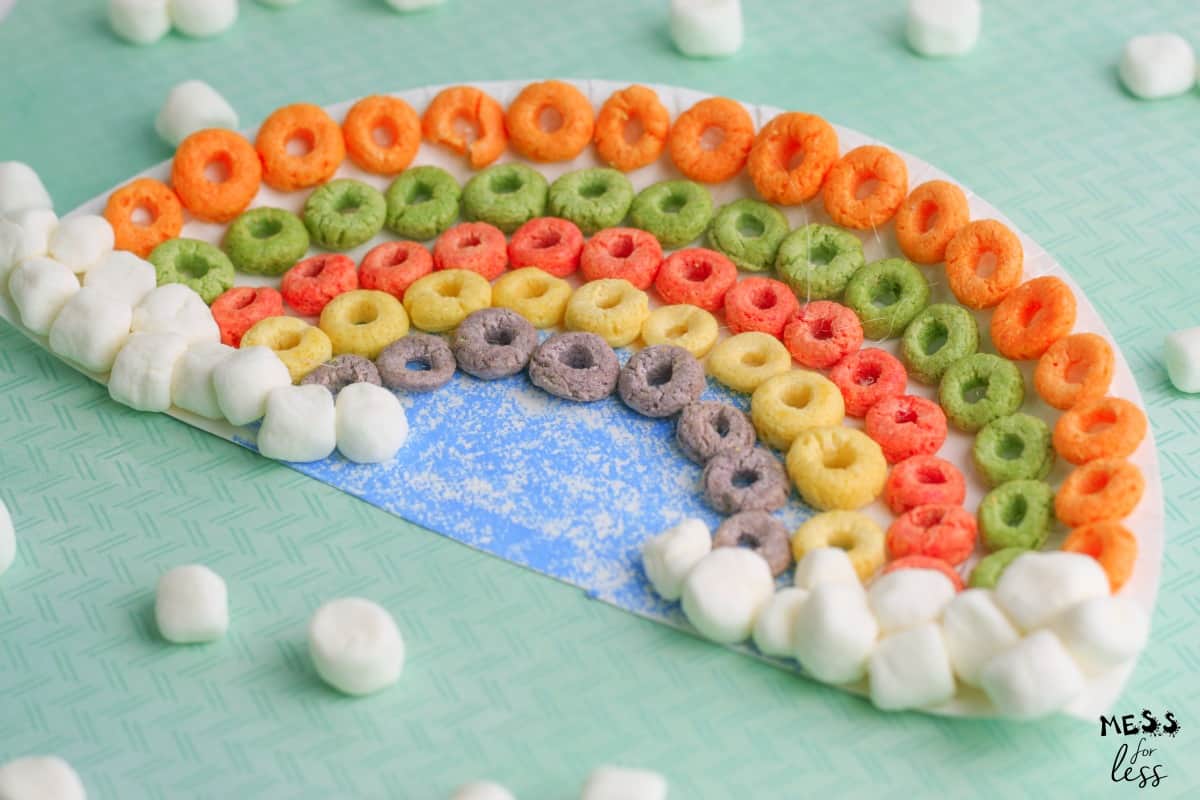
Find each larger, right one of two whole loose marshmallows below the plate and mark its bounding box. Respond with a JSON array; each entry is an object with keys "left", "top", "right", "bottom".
[{"left": 308, "top": 597, "right": 404, "bottom": 694}]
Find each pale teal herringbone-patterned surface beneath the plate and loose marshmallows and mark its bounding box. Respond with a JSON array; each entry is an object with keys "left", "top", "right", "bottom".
[{"left": 0, "top": 0, "right": 1200, "bottom": 800}]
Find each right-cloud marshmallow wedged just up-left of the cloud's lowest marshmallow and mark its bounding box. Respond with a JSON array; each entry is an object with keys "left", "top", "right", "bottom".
[{"left": 940, "top": 587, "right": 1021, "bottom": 686}]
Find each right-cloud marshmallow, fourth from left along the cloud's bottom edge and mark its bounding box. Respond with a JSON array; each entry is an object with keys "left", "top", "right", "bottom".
[{"left": 796, "top": 583, "right": 880, "bottom": 684}]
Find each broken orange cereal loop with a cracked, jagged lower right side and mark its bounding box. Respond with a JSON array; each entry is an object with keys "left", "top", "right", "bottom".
[{"left": 421, "top": 86, "right": 509, "bottom": 169}]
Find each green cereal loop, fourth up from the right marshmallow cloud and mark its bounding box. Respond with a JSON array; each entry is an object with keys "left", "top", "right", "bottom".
[{"left": 937, "top": 353, "right": 1025, "bottom": 433}]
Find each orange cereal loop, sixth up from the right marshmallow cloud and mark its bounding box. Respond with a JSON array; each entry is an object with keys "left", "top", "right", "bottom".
[{"left": 946, "top": 219, "right": 1025, "bottom": 311}]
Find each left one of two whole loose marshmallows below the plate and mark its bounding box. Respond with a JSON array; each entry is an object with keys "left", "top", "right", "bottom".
[{"left": 154, "top": 564, "right": 229, "bottom": 644}]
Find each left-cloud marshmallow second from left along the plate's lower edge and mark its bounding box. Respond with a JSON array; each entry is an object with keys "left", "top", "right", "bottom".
[{"left": 50, "top": 287, "right": 133, "bottom": 373}]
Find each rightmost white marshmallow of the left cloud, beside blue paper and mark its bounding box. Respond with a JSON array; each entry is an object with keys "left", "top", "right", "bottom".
[{"left": 335, "top": 383, "right": 408, "bottom": 464}]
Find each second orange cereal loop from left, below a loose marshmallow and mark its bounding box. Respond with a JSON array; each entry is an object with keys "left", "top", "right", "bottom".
[{"left": 170, "top": 128, "right": 263, "bottom": 222}]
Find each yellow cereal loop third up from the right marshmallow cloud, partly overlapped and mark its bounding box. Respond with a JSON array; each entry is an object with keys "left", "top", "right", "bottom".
[{"left": 750, "top": 369, "right": 846, "bottom": 451}]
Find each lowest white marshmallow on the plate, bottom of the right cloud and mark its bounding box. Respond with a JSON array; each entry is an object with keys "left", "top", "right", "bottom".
[{"left": 979, "top": 631, "right": 1084, "bottom": 717}]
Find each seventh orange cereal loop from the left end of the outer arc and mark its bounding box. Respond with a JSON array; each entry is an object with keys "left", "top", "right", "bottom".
[{"left": 595, "top": 84, "right": 671, "bottom": 173}]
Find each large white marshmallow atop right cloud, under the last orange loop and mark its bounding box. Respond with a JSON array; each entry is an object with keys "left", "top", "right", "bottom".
[{"left": 996, "top": 552, "right": 1110, "bottom": 631}]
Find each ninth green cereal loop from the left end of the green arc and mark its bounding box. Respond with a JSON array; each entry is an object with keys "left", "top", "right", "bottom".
[{"left": 775, "top": 223, "right": 866, "bottom": 301}]
